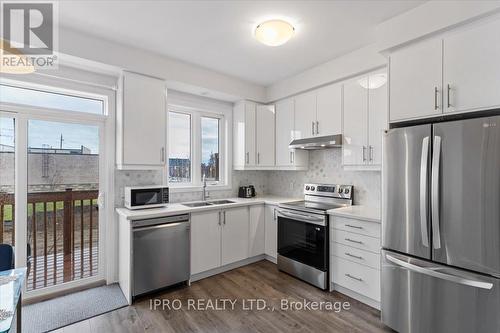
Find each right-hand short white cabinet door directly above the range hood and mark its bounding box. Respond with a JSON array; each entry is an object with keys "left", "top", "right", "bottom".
[{"left": 315, "top": 84, "right": 342, "bottom": 136}]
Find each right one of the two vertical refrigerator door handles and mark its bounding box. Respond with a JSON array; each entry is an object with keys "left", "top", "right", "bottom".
[{"left": 431, "top": 135, "right": 441, "bottom": 250}]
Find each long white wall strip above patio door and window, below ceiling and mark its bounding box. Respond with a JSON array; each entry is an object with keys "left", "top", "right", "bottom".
[{"left": 59, "top": 28, "right": 265, "bottom": 101}]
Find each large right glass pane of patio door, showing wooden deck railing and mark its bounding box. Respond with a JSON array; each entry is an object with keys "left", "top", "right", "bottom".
[{"left": 26, "top": 119, "right": 101, "bottom": 291}]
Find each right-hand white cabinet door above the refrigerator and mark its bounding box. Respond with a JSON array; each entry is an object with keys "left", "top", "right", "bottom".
[{"left": 444, "top": 21, "right": 500, "bottom": 112}]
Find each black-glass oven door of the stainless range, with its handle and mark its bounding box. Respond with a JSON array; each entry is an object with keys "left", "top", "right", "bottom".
[{"left": 277, "top": 209, "right": 328, "bottom": 272}]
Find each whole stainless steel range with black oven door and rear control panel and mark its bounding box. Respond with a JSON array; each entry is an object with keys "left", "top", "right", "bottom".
[{"left": 277, "top": 184, "right": 353, "bottom": 289}]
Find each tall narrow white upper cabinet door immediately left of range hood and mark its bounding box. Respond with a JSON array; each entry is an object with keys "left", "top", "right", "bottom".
[{"left": 275, "top": 98, "right": 294, "bottom": 166}]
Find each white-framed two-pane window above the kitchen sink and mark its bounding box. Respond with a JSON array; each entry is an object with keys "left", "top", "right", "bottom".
[{"left": 167, "top": 92, "right": 232, "bottom": 191}]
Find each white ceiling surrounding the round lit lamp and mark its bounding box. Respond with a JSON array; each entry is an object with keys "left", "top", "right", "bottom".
[{"left": 59, "top": 0, "right": 424, "bottom": 86}]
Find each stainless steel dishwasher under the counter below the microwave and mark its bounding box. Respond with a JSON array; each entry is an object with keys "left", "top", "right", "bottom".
[{"left": 132, "top": 214, "right": 190, "bottom": 297}]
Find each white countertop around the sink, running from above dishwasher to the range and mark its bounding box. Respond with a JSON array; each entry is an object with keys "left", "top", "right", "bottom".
[{"left": 116, "top": 195, "right": 303, "bottom": 220}]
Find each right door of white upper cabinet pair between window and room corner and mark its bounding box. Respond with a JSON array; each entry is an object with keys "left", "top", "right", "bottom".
[{"left": 256, "top": 105, "right": 275, "bottom": 166}]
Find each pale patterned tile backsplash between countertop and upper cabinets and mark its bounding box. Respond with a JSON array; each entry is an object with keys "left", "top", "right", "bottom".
[{"left": 115, "top": 149, "right": 381, "bottom": 207}]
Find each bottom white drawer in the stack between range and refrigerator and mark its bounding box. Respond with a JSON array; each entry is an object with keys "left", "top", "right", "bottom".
[{"left": 331, "top": 257, "right": 380, "bottom": 302}]
